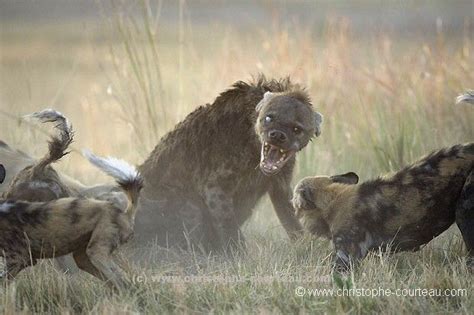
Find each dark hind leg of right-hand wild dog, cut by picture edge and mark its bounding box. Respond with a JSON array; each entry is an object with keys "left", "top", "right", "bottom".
[{"left": 456, "top": 170, "right": 474, "bottom": 267}]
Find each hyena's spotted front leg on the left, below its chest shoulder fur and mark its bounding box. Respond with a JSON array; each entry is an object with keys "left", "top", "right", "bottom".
[{"left": 205, "top": 184, "right": 245, "bottom": 250}]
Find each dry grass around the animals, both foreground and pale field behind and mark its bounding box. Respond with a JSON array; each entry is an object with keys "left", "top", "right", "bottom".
[{"left": 0, "top": 0, "right": 474, "bottom": 314}]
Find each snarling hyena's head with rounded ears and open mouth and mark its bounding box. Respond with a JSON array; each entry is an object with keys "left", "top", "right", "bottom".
[{"left": 255, "top": 91, "right": 323, "bottom": 175}]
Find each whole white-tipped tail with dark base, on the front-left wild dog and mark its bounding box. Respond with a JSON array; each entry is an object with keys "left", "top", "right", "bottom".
[{"left": 82, "top": 150, "right": 143, "bottom": 220}]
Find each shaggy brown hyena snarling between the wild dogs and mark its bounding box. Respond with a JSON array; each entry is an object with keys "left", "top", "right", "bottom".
[{"left": 136, "top": 77, "right": 322, "bottom": 250}]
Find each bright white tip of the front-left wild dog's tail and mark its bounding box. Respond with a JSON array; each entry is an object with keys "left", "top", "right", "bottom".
[{"left": 82, "top": 150, "right": 140, "bottom": 182}]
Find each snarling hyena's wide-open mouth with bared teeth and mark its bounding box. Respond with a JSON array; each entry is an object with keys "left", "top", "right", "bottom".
[{"left": 260, "top": 142, "right": 296, "bottom": 175}]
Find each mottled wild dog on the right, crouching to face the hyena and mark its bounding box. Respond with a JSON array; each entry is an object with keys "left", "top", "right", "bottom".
[{"left": 293, "top": 94, "right": 474, "bottom": 270}]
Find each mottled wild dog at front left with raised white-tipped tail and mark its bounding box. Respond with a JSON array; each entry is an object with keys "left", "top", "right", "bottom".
[{"left": 0, "top": 153, "right": 142, "bottom": 287}]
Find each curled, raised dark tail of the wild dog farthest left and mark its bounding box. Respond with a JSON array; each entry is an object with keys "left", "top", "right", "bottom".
[{"left": 25, "top": 109, "right": 74, "bottom": 173}]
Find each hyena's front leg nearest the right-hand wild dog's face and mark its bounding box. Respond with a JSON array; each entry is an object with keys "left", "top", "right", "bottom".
[{"left": 269, "top": 178, "right": 303, "bottom": 239}]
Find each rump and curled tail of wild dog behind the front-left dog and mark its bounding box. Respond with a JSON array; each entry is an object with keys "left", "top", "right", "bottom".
[{"left": 4, "top": 109, "right": 73, "bottom": 201}]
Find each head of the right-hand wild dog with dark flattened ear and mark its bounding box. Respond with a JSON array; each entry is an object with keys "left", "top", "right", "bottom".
[{"left": 293, "top": 172, "right": 359, "bottom": 217}]
